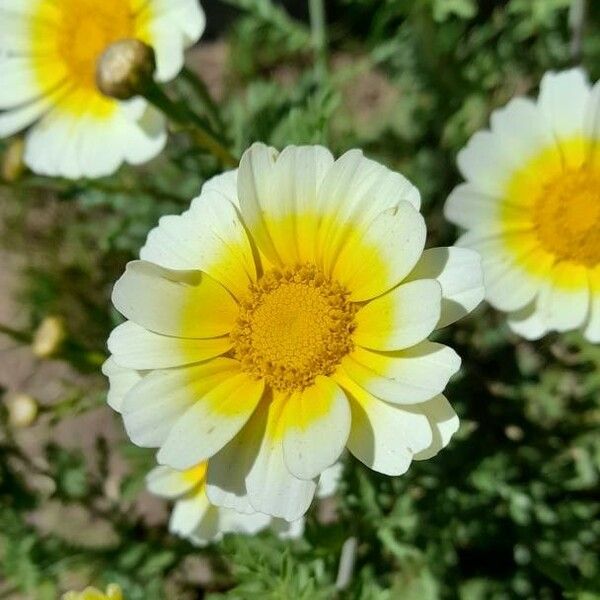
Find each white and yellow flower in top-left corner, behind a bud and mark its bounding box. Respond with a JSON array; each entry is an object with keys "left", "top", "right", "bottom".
[{"left": 0, "top": 0, "right": 204, "bottom": 178}]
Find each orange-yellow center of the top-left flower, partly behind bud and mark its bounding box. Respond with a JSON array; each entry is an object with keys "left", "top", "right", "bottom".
[{"left": 56, "top": 0, "right": 135, "bottom": 89}]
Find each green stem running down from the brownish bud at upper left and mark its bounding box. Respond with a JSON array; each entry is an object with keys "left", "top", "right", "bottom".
[{"left": 144, "top": 82, "right": 238, "bottom": 167}]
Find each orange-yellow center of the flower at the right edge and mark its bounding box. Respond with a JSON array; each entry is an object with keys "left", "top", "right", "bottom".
[{"left": 533, "top": 167, "right": 600, "bottom": 267}]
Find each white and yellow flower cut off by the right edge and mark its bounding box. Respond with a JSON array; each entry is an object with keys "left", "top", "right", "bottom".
[{"left": 445, "top": 69, "right": 600, "bottom": 342}]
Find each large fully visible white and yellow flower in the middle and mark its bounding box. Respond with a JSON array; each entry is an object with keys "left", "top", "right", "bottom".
[{"left": 104, "top": 144, "right": 483, "bottom": 521}]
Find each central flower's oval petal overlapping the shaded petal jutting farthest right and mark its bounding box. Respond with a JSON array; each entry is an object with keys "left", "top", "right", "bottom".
[{"left": 354, "top": 279, "right": 442, "bottom": 350}]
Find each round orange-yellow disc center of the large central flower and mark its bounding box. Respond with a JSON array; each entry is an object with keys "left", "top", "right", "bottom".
[{"left": 231, "top": 265, "right": 356, "bottom": 392}]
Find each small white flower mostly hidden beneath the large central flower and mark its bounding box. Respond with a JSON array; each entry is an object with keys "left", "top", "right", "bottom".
[{"left": 146, "top": 462, "right": 341, "bottom": 546}]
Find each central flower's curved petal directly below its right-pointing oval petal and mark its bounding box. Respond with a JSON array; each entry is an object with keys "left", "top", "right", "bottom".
[{"left": 342, "top": 341, "right": 460, "bottom": 404}]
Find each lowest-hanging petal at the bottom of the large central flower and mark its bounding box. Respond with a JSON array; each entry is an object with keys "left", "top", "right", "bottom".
[{"left": 246, "top": 397, "right": 317, "bottom": 521}]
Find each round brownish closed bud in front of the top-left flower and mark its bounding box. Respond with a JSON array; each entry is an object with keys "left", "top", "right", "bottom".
[{"left": 96, "top": 39, "right": 156, "bottom": 100}]
